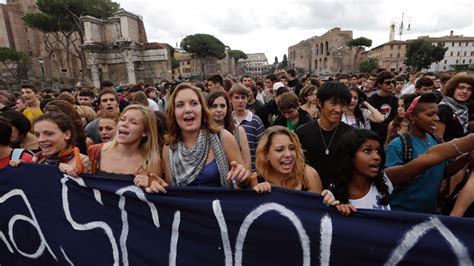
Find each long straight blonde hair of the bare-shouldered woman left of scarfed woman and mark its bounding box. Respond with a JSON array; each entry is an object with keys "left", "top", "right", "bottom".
[{"left": 104, "top": 104, "right": 161, "bottom": 170}]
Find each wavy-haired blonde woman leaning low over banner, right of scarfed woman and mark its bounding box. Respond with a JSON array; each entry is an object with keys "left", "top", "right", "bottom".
[{"left": 250, "top": 126, "right": 339, "bottom": 205}]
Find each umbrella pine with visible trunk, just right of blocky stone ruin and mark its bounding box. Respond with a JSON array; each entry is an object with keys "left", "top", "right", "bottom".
[{"left": 181, "top": 33, "right": 225, "bottom": 76}]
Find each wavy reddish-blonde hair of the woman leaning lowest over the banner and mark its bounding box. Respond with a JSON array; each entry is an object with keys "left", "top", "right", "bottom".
[{"left": 256, "top": 126, "right": 308, "bottom": 188}]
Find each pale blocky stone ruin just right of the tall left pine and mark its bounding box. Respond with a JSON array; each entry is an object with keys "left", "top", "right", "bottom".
[{"left": 81, "top": 10, "right": 172, "bottom": 87}]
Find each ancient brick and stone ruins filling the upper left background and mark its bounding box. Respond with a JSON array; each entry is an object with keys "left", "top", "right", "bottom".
[{"left": 0, "top": 0, "right": 171, "bottom": 88}]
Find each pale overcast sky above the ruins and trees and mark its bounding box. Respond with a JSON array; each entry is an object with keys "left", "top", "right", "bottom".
[{"left": 113, "top": 0, "right": 474, "bottom": 63}]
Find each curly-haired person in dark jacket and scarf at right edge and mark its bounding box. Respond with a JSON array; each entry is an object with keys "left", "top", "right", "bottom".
[{"left": 435, "top": 72, "right": 474, "bottom": 141}]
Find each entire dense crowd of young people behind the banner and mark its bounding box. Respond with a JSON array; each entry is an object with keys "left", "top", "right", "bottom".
[{"left": 0, "top": 69, "right": 474, "bottom": 217}]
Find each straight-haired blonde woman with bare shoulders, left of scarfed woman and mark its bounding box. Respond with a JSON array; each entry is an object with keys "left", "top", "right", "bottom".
[{"left": 88, "top": 104, "right": 162, "bottom": 184}]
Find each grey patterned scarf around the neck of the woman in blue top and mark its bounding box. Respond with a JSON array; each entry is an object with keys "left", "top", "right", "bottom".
[{"left": 168, "top": 129, "right": 231, "bottom": 188}]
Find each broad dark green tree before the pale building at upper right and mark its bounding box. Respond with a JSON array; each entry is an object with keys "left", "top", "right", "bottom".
[{"left": 404, "top": 39, "right": 448, "bottom": 71}]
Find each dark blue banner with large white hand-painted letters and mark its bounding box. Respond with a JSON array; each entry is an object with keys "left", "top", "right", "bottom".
[{"left": 0, "top": 164, "right": 474, "bottom": 266}]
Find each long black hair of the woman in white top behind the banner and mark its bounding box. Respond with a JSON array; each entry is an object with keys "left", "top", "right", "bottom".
[{"left": 332, "top": 129, "right": 390, "bottom": 205}]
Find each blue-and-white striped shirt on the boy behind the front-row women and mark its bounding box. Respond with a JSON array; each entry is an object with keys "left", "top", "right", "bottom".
[{"left": 232, "top": 110, "right": 265, "bottom": 171}]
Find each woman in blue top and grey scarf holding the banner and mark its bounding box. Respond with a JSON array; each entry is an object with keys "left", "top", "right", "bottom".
[{"left": 150, "top": 83, "right": 250, "bottom": 192}]
